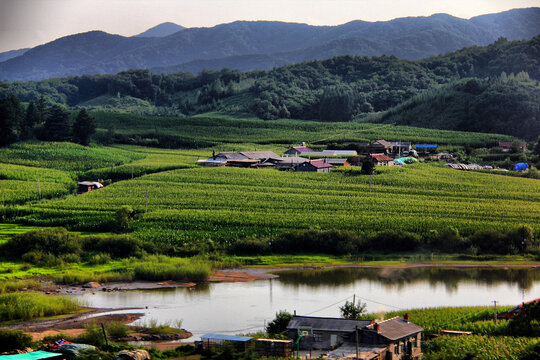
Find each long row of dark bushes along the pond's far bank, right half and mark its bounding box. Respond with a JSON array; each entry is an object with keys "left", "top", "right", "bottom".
[{"left": 229, "top": 226, "right": 540, "bottom": 256}]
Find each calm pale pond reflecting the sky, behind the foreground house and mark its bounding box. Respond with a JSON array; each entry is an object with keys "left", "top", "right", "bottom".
[{"left": 78, "top": 267, "right": 540, "bottom": 340}]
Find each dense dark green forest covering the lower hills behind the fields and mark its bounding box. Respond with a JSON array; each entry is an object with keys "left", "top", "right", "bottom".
[{"left": 0, "top": 36, "right": 540, "bottom": 139}]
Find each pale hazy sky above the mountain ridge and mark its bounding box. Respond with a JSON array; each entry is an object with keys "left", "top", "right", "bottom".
[{"left": 0, "top": 0, "right": 540, "bottom": 52}]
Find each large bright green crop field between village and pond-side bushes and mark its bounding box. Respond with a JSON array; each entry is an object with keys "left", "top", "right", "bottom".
[{"left": 10, "top": 164, "right": 540, "bottom": 244}]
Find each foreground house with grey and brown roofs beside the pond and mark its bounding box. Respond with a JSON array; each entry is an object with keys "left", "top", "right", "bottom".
[{"left": 287, "top": 315, "right": 423, "bottom": 360}]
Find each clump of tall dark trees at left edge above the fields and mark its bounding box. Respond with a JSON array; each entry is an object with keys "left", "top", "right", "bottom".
[{"left": 0, "top": 96, "right": 96, "bottom": 146}]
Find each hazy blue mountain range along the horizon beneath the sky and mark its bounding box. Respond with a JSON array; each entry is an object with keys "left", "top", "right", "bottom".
[{"left": 0, "top": 8, "right": 540, "bottom": 80}]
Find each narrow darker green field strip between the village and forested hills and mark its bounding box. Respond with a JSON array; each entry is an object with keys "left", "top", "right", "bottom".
[{"left": 92, "top": 111, "right": 512, "bottom": 147}]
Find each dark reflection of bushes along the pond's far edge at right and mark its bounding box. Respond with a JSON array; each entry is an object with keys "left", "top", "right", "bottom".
[{"left": 277, "top": 267, "right": 540, "bottom": 292}]
